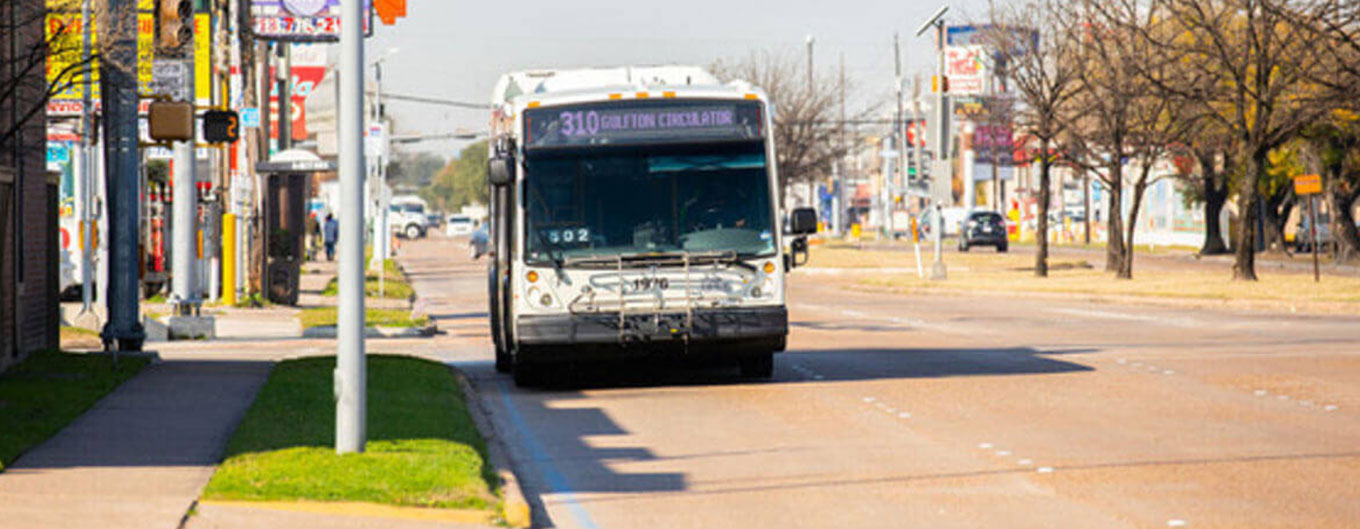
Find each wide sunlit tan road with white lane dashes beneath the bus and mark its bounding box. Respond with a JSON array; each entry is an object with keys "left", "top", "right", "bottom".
[{"left": 403, "top": 233, "right": 1360, "bottom": 529}]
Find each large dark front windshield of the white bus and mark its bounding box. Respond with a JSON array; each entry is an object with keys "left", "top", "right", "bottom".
[{"left": 524, "top": 141, "right": 774, "bottom": 262}]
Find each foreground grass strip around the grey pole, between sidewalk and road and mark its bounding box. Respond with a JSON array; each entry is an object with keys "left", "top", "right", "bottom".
[{"left": 204, "top": 355, "right": 498, "bottom": 509}]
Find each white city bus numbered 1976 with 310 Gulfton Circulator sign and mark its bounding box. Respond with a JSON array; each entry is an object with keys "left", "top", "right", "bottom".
[{"left": 488, "top": 67, "right": 816, "bottom": 383}]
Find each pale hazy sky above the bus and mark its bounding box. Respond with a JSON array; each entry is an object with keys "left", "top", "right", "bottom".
[{"left": 353, "top": 0, "right": 986, "bottom": 158}]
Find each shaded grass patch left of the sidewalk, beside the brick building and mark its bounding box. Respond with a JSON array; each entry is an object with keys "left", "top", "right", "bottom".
[{"left": 0, "top": 351, "right": 150, "bottom": 471}]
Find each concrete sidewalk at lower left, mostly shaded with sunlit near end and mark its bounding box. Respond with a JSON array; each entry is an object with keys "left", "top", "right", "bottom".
[{"left": 0, "top": 359, "right": 272, "bottom": 529}]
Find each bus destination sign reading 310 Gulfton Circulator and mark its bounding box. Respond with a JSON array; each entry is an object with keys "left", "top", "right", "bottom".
[{"left": 525, "top": 101, "right": 762, "bottom": 148}]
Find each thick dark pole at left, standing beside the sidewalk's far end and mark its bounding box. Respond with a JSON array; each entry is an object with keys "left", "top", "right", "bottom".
[{"left": 99, "top": 0, "right": 146, "bottom": 351}]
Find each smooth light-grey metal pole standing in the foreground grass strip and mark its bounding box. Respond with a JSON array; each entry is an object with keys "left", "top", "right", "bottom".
[{"left": 335, "top": 0, "right": 367, "bottom": 454}]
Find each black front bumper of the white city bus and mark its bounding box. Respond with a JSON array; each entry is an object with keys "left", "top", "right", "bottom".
[{"left": 515, "top": 307, "right": 789, "bottom": 352}]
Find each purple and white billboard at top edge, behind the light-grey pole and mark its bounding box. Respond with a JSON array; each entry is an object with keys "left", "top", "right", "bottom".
[{"left": 250, "top": 0, "right": 373, "bottom": 42}]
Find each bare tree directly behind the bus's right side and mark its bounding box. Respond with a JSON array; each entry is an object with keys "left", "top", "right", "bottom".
[{"left": 711, "top": 52, "right": 872, "bottom": 208}]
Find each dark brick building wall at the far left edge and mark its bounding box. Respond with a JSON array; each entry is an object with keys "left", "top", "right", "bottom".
[{"left": 0, "top": 0, "right": 60, "bottom": 370}]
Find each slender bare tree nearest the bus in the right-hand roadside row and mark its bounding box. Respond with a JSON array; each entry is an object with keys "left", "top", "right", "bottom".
[{"left": 986, "top": 0, "right": 1078, "bottom": 277}]
